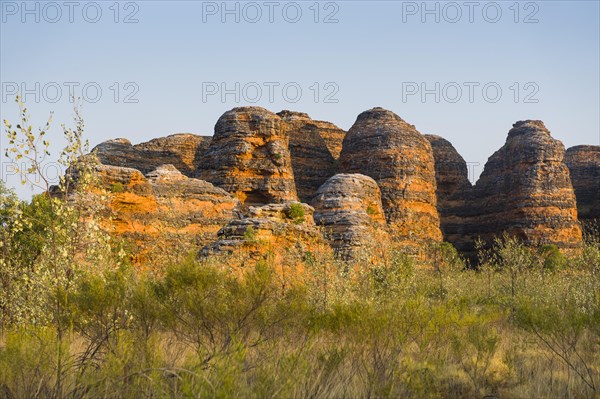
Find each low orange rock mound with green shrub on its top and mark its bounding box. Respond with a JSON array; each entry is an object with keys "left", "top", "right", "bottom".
[{"left": 198, "top": 202, "right": 326, "bottom": 263}]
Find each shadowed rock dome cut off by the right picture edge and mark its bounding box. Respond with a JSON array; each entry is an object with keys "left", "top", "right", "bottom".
[{"left": 565, "top": 145, "right": 600, "bottom": 222}]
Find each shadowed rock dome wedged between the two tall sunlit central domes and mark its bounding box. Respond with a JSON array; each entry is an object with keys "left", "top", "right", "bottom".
[{"left": 277, "top": 111, "right": 345, "bottom": 202}]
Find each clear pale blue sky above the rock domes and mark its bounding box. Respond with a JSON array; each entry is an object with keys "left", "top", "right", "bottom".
[{"left": 0, "top": 0, "right": 600, "bottom": 197}]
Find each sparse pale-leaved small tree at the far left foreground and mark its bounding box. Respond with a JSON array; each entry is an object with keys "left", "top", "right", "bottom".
[{"left": 3, "top": 96, "right": 119, "bottom": 398}]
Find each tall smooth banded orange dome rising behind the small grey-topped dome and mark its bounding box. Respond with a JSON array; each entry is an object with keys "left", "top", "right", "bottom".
[{"left": 340, "top": 108, "right": 442, "bottom": 252}]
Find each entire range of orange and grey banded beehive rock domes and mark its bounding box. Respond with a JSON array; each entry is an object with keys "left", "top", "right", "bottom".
[{"left": 68, "top": 107, "right": 588, "bottom": 263}]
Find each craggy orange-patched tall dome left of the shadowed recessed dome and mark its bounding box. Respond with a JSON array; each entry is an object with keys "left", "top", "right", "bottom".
[{"left": 197, "top": 107, "right": 297, "bottom": 205}]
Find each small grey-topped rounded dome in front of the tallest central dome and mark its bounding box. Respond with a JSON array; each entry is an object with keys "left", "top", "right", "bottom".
[{"left": 312, "top": 173, "right": 385, "bottom": 259}]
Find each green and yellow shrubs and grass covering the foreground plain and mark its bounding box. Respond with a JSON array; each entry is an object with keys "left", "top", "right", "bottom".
[{"left": 0, "top": 242, "right": 600, "bottom": 398}]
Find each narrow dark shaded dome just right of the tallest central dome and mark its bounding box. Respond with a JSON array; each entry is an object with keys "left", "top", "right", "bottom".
[{"left": 425, "top": 134, "right": 472, "bottom": 248}]
